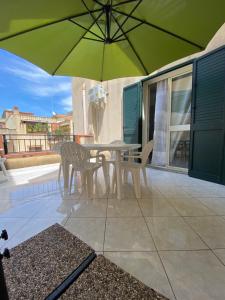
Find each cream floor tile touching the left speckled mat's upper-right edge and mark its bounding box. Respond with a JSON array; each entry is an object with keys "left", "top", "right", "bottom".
[{"left": 65, "top": 218, "right": 105, "bottom": 251}]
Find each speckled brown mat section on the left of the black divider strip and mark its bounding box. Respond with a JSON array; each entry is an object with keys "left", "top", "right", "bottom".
[{"left": 0, "top": 224, "right": 93, "bottom": 300}]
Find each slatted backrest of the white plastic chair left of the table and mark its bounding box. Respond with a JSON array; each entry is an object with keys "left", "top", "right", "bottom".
[{"left": 61, "top": 142, "right": 90, "bottom": 170}]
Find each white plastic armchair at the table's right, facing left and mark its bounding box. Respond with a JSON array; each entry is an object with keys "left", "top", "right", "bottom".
[{"left": 113, "top": 140, "right": 154, "bottom": 198}]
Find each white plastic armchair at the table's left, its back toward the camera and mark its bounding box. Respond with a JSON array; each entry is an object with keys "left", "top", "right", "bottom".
[{"left": 61, "top": 142, "right": 108, "bottom": 197}]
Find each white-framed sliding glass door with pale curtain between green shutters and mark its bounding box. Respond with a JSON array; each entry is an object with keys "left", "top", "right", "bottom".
[{"left": 143, "top": 65, "right": 192, "bottom": 169}]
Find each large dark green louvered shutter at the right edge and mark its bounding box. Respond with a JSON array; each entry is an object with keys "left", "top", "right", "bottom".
[{"left": 189, "top": 48, "right": 225, "bottom": 183}]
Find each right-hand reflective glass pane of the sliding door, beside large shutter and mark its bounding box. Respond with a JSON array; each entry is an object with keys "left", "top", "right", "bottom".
[{"left": 169, "top": 73, "right": 192, "bottom": 168}]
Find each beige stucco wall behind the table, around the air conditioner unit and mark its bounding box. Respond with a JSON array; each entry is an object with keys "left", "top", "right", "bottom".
[{"left": 72, "top": 77, "right": 142, "bottom": 143}]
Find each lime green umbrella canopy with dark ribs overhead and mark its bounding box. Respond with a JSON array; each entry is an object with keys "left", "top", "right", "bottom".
[{"left": 0, "top": 0, "right": 225, "bottom": 80}]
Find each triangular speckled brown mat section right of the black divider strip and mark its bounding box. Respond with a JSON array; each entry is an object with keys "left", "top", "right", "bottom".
[{"left": 60, "top": 255, "right": 168, "bottom": 300}]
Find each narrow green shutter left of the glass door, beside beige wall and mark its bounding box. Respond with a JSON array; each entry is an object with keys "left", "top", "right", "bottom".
[{"left": 123, "top": 83, "right": 141, "bottom": 144}]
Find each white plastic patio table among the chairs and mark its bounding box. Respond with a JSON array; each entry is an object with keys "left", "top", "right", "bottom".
[{"left": 82, "top": 144, "right": 141, "bottom": 199}]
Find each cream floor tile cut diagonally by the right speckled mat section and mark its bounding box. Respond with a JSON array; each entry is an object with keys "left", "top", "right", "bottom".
[{"left": 104, "top": 252, "right": 175, "bottom": 300}]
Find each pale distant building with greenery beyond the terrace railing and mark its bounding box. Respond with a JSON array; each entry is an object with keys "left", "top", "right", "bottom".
[{"left": 0, "top": 106, "right": 73, "bottom": 153}]
